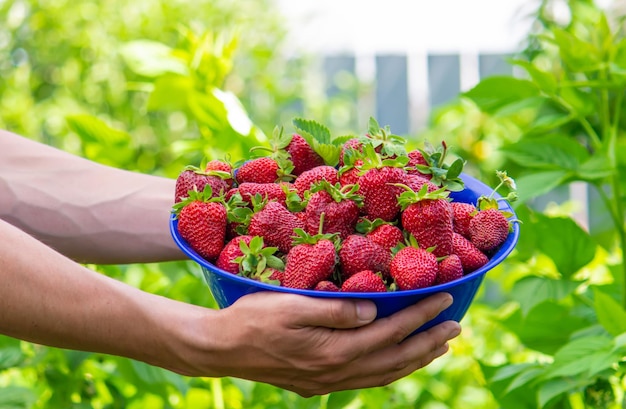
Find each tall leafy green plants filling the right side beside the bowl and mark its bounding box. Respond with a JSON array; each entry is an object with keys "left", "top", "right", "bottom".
[{"left": 446, "top": 1, "right": 626, "bottom": 408}]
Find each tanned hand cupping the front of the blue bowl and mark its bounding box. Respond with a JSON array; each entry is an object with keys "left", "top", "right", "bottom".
[{"left": 179, "top": 292, "right": 460, "bottom": 397}]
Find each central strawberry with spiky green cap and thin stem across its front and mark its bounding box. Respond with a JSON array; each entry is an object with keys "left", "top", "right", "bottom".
[{"left": 305, "top": 181, "right": 361, "bottom": 239}]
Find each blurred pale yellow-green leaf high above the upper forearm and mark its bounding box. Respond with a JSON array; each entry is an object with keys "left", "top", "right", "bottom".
[{"left": 120, "top": 40, "right": 189, "bottom": 78}]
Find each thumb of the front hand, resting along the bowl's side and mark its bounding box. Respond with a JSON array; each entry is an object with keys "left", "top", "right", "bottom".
[{"left": 288, "top": 297, "right": 376, "bottom": 329}]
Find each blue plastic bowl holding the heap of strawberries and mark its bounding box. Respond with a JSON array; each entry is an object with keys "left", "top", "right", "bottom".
[{"left": 170, "top": 174, "right": 519, "bottom": 332}]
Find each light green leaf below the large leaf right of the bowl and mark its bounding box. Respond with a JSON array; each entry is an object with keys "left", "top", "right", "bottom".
[{"left": 511, "top": 276, "right": 579, "bottom": 314}]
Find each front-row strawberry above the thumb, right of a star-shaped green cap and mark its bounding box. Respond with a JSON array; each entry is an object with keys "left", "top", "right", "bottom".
[{"left": 282, "top": 229, "right": 337, "bottom": 289}]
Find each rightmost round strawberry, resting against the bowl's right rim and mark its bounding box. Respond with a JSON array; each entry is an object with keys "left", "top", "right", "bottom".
[{"left": 469, "top": 208, "right": 509, "bottom": 253}]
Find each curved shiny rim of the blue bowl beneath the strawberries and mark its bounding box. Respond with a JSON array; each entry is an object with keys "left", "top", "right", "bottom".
[{"left": 170, "top": 173, "right": 520, "bottom": 299}]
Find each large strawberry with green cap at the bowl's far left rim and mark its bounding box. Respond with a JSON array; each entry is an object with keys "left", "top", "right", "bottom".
[{"left": 173, "top": 185, "right": 227, "bottom": 262}]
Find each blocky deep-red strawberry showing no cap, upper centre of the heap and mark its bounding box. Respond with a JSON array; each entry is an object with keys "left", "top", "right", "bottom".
[{"left": 358, "top": 166, "right": 406, "bottom": 222}]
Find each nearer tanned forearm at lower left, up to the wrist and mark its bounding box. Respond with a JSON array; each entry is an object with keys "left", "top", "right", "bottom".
[{"left": 0, "top": 220, "right": 212, "bottom": 373}]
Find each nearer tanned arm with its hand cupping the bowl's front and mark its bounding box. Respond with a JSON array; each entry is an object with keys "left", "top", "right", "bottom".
[{"left": 0, "top": 215, "right": 460, "bottom": 396}]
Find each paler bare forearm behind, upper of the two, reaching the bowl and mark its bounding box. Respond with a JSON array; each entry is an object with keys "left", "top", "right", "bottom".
[{"left": 0, "top": 131, "right": 184, "bottom": 264}]
